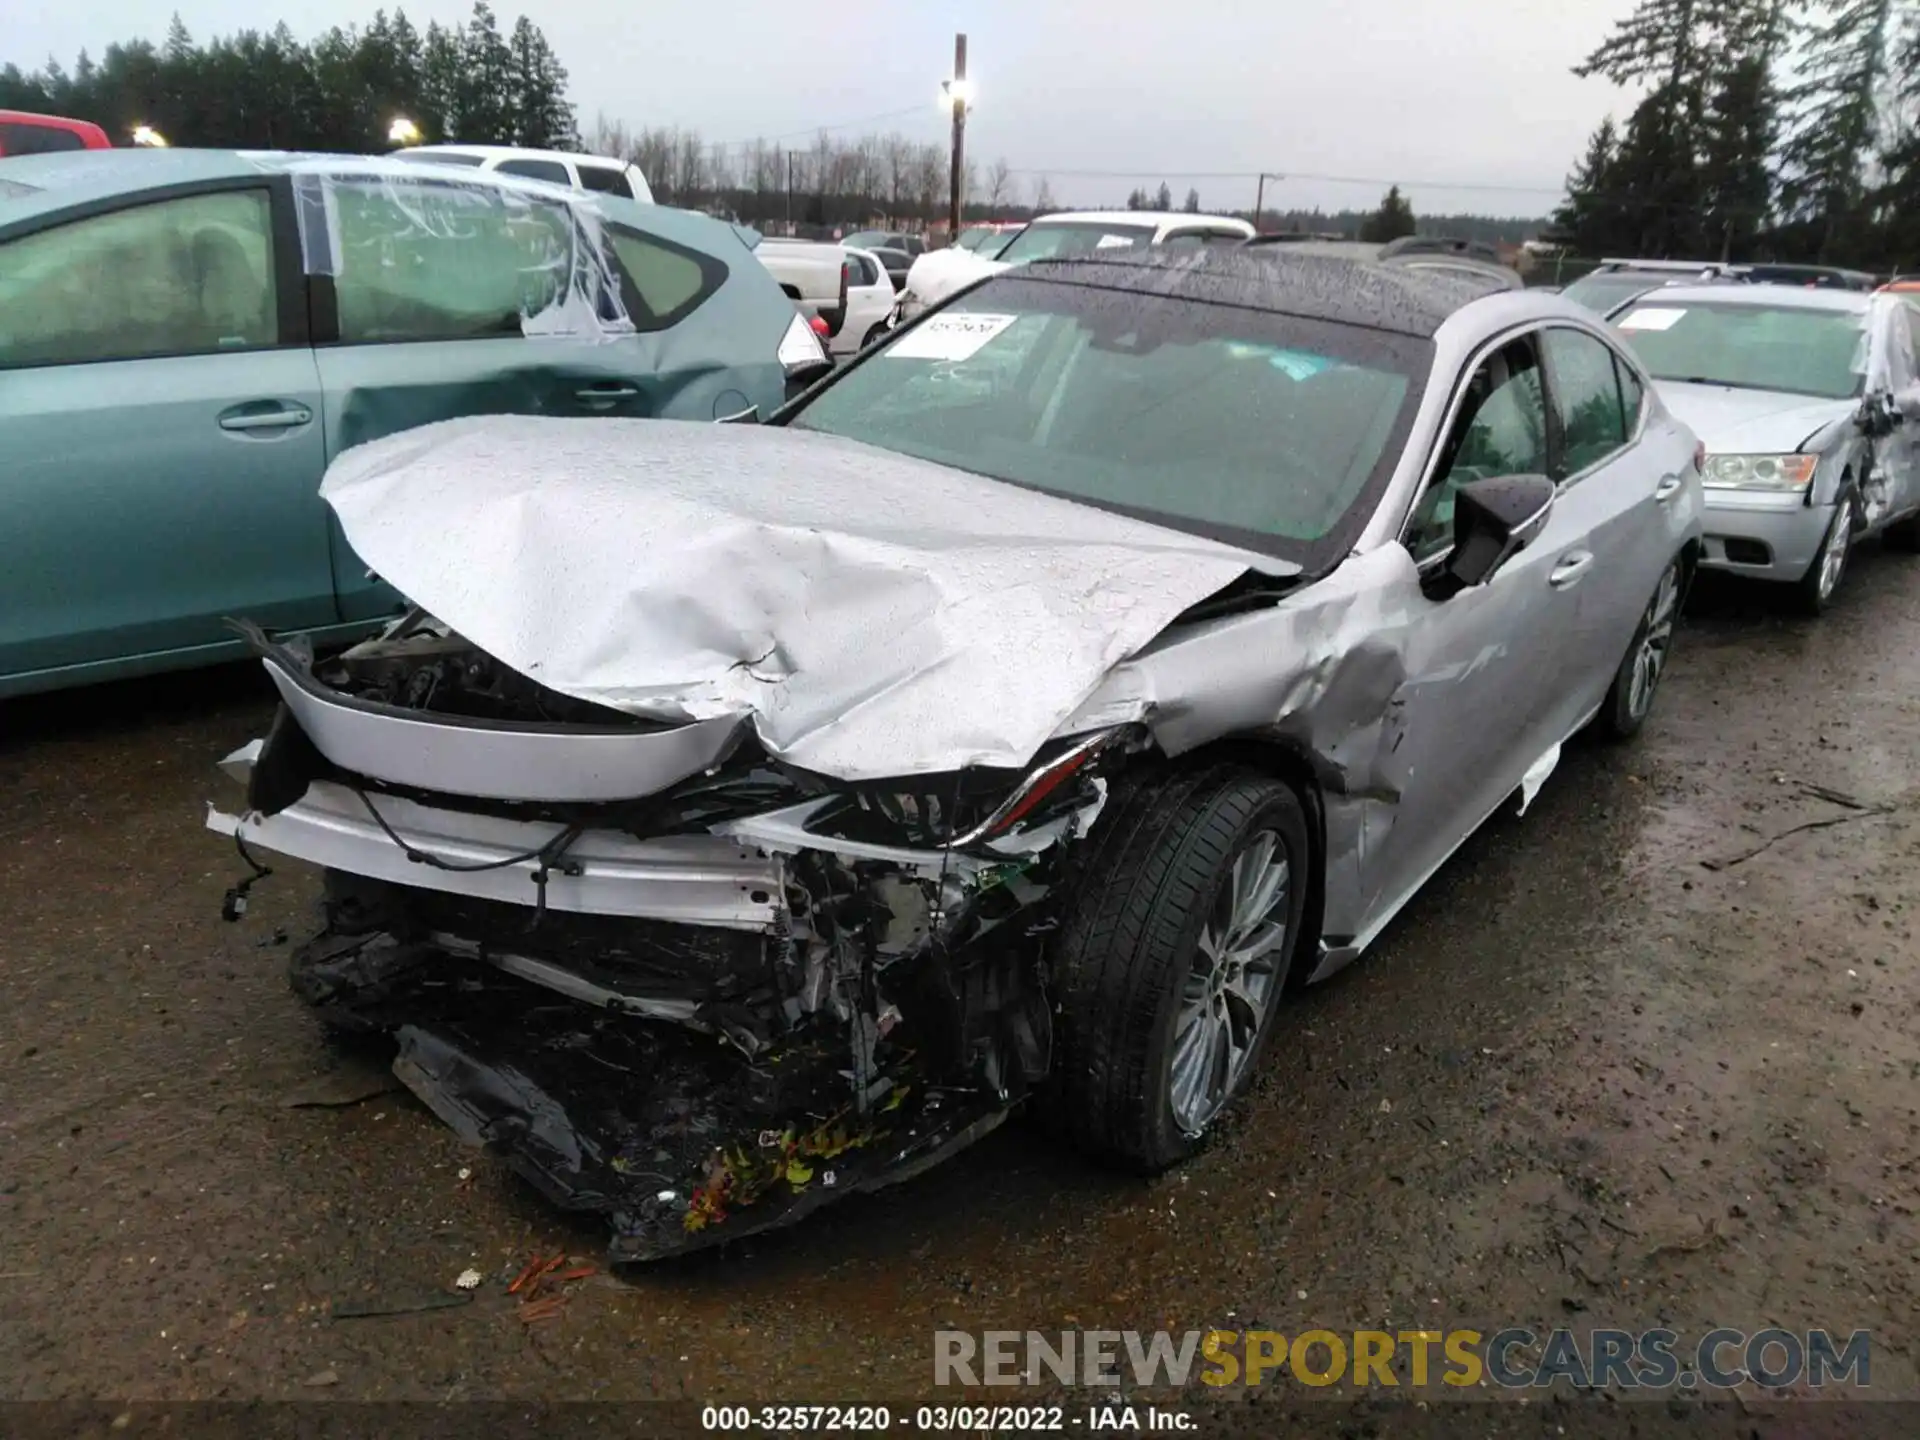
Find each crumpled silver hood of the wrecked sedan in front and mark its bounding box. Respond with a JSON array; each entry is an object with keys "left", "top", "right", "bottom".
[{"left": 321, "top": 417, "right": 1290, "bottom": 780}]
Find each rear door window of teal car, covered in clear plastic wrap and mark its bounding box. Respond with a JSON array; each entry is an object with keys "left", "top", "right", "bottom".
[{"left": 292, "top": 159, "right": 634, "bottom": 340}]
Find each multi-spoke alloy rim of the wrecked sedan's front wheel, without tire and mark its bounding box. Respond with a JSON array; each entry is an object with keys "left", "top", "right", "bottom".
[{"left": 1167, "top": 829, "right": 1290, "bottom": 1135}]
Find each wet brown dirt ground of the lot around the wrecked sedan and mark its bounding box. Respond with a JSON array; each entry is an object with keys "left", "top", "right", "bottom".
[{"left": 0, "top": 547, "right": 1920, "bottom": 1434}]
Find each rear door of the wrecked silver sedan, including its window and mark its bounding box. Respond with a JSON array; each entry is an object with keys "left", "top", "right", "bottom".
[{"left": 1544, "top": 326, "right": 1688, "bottom": 733}]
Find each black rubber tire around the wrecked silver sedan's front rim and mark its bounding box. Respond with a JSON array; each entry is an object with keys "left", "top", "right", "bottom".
[{"left": 1041, "top": 768, "right": 1315, "bottom": 1173}]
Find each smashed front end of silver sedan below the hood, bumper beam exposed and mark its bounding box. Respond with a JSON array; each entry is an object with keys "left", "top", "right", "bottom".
[{"left": 207, "top": 612, "right": 1137, "bottom": 1261}]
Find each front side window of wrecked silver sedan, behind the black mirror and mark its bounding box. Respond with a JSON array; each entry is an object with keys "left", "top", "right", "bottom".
[{"left": 1407, "top": 340, "right": 1548, "bottom": 561}]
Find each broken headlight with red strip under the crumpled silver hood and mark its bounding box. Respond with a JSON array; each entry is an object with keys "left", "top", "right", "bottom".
[{"left": 808, "top": 726, "right": 1133, "bottom": 849}]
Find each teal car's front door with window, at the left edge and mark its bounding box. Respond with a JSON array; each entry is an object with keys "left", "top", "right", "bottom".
[{"left": 0, "top": 182, "right": 336, "bottom": 695}]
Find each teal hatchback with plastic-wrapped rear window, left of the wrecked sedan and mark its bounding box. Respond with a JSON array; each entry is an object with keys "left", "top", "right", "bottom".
[{"left": 0, "top": 150, "right": 824, "bottom": 697}]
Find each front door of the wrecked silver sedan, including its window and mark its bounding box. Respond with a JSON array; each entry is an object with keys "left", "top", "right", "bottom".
[{"left": 1369, "top": 332, "right": 1588, "bottom": 914}]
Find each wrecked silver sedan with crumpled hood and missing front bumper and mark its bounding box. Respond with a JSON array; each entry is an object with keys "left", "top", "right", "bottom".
[{"left": 207, "top": 252, "right": 1701, "bottom": 1260}]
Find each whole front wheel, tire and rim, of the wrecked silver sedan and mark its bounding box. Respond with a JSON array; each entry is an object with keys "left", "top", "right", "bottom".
[{"left": 1043, "top": 770, "right": 1311, "bottom": 1171}]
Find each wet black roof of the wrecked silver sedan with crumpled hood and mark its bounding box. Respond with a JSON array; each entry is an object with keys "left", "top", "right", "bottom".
[{"left": 1008, "top": 249, "right": 1511, "bottom": 338}]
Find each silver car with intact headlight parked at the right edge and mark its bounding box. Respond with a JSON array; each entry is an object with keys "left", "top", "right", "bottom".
[{"left": 1613, "top": 284, "right": 1920, "bottom": 614}]
